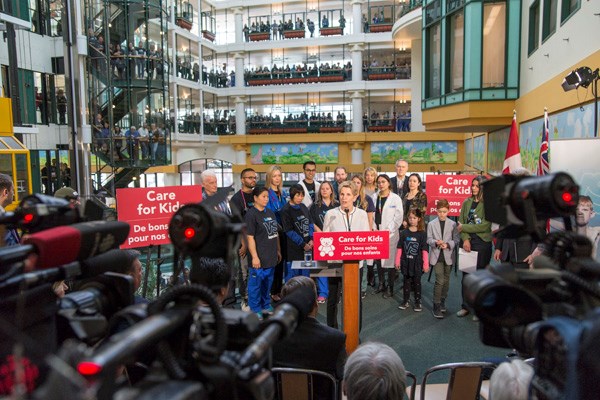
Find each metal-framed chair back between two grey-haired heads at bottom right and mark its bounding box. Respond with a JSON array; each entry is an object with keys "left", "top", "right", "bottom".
[{"left": 415, "top": 362, "right": 496, "bottom": 400}]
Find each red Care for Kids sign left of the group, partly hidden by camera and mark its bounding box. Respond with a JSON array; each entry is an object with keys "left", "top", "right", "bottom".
[{"left": 117, "top": 185, "right": 202, "bottom": 249}]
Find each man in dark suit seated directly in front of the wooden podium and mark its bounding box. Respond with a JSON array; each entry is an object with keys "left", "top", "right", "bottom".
[{"left": 273, "top": 276, "right": 347, "bottom": 399}]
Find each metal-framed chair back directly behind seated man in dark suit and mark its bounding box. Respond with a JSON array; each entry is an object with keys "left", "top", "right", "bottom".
[{"left": 271, "top": 368, "right": 338, "bottom": 400}]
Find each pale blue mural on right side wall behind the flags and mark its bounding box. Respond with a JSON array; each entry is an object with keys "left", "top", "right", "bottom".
[{"left": 516, "top": 104, "right": 594, "bottom": 174}]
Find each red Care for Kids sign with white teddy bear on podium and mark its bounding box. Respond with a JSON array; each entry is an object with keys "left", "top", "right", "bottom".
[{"left": 313, "top": 231, "right": 390, "bottom": 261}]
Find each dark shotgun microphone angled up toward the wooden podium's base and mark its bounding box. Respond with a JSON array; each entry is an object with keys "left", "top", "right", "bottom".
[{"left": 239, "top": 286, "right": 317, "bottom": 368}]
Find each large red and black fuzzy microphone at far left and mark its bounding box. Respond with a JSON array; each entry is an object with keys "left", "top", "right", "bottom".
[{"left": 23, "top": 221, "right": 129, "bottom": 269}]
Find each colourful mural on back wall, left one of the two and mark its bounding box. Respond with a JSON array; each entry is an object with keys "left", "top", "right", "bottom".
[{"left": 250, "top": 143, "right": 338, "bottom": 165}]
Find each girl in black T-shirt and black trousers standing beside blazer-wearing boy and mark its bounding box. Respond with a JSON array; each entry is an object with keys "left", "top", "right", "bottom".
[{"left": 395, "top": 208, "right": 429, "bottom": 312}]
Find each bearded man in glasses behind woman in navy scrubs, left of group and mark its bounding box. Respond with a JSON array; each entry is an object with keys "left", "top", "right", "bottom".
[{"left": 229, "top": 168, "right": 258, "bottom": 311}]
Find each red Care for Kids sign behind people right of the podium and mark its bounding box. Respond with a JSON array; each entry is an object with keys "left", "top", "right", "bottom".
[{"left": 427, "top": 175, "right": 477, "bottom": 217}]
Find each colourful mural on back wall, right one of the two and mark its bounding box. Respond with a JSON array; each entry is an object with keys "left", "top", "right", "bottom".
[{"left": 371, "top": 141, "right": 458, "bottom": 164}]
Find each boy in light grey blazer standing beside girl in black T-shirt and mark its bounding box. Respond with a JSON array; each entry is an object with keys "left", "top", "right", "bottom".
[{"left": 427, "top": 199, "right": 460, "bottom": 318}]
